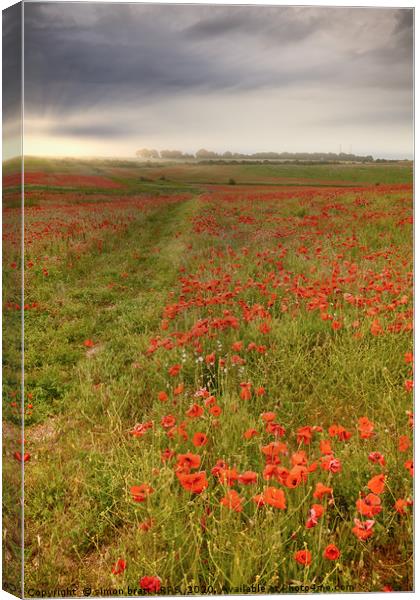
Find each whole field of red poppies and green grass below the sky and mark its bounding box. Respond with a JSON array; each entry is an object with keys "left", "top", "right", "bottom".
[{"left": 3, "top": 160, "right": 413, "bottom": 597}]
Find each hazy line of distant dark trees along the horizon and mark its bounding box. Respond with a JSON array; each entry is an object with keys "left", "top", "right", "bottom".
[{"left": 136, "top": 148, "right": 374, "bottom": 162}]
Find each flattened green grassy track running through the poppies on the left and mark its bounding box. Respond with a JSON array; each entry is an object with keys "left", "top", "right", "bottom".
[{"left": 5, "top": 197, "right": 197, "bottom": 585}]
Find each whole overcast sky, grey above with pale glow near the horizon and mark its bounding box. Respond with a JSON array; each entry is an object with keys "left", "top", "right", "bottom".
[{"left": 1, "top": 2, "right": 413, "bottom": 158}]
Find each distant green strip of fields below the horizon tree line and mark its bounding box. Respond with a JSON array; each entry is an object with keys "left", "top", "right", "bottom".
[{"left": 4, "top": 157, "right": 413, "bottom": 187}]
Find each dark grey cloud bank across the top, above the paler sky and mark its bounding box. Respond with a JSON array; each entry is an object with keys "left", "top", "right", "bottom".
[{"left": 25, "top": 3, "right": 412, "bottom": 116}]
